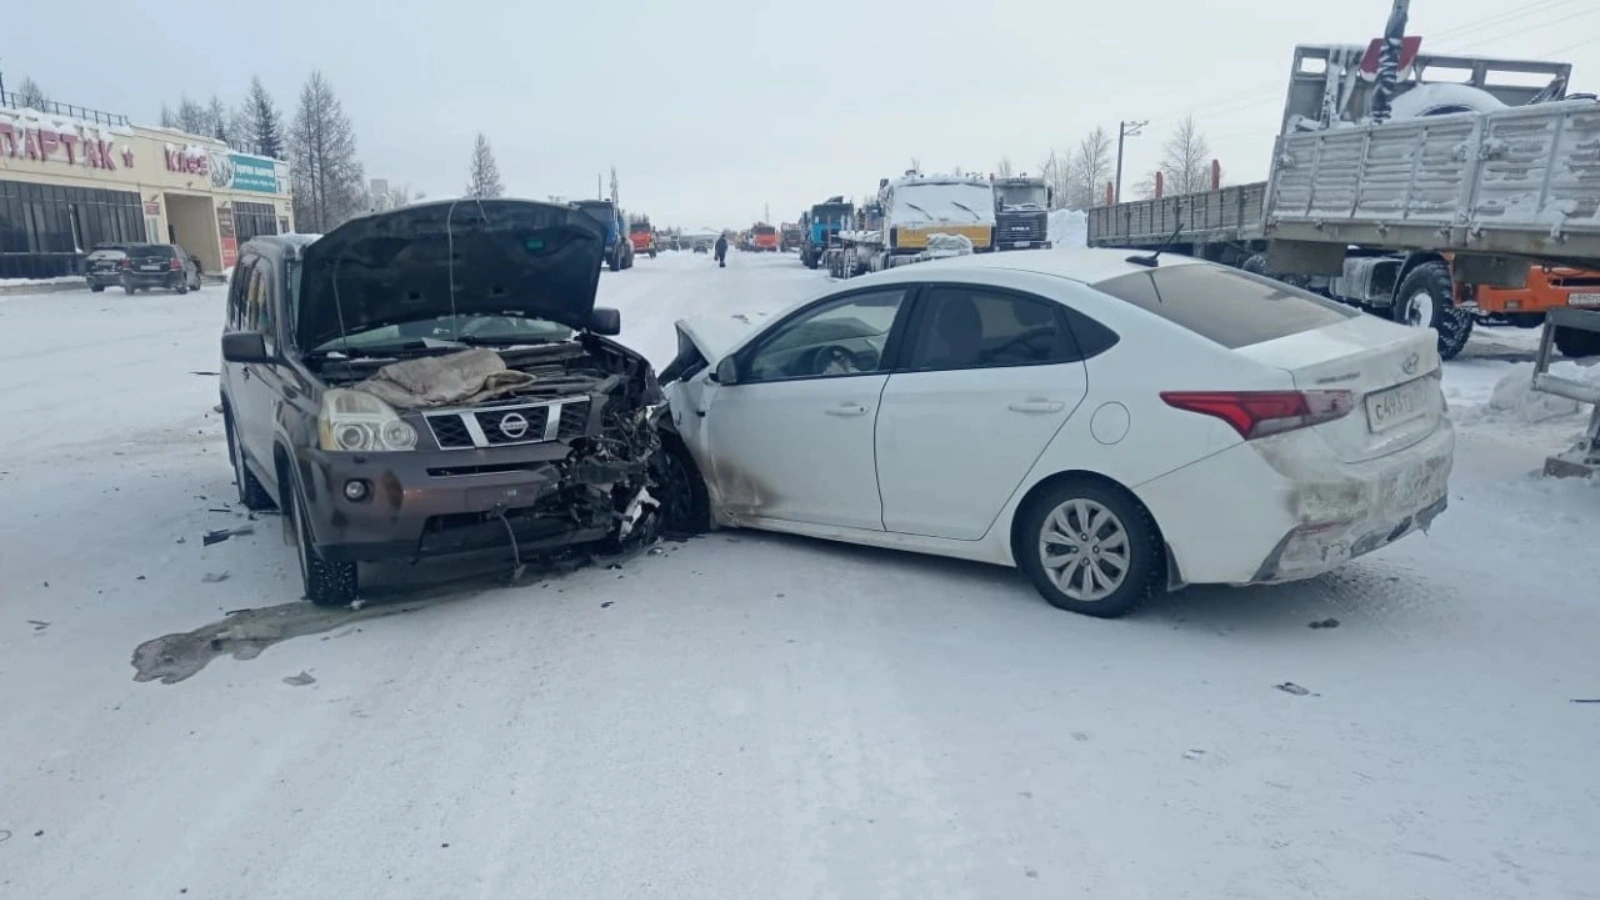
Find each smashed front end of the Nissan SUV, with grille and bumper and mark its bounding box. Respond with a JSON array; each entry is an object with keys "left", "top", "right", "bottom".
[{"left": 298, "top": 335, "right": 661, "bottom": 562}]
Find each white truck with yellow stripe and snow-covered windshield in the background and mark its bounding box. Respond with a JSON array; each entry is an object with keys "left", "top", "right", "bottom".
[{"left": 822, "top": 171, "right": 995, "bottom": 279}]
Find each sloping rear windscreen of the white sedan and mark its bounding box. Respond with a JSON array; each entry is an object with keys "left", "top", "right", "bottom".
[{"left": 1094, "top": 264, "right": 1360, "bottom": 349}]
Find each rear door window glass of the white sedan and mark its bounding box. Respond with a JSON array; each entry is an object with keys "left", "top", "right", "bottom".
[{"left": 907, "top": 285, "right": 1082, "bottom": 372}]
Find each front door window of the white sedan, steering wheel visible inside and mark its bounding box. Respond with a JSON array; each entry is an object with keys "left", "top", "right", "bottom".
[{"left": 741, "top": 288, "right": 906, "bottom": 381}]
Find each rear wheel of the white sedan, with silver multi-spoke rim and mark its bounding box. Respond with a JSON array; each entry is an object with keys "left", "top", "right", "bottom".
[{"left": 1016, "top": 479, "right": 1165, "bottom": 618}]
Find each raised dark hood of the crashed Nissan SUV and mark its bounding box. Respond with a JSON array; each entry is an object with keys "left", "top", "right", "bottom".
[{"left": 294, "top": 200, "right": 605, "bottom": 349}]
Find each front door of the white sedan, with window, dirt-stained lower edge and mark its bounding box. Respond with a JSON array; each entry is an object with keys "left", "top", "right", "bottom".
[{"left": 702, "top": 288, "right": 906, "bottom": 532}]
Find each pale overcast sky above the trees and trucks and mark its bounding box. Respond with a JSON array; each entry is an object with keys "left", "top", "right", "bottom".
[{"left": 0, "top": 0, "right": 1600, "bottom": 227}]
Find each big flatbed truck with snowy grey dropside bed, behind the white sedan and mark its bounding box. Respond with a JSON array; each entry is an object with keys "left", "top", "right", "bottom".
[{"left": 1088, "top": 35, "right": 1600, "bottom": 359}]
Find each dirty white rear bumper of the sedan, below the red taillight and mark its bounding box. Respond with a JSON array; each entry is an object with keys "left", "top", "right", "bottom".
[{"left": 1134, "top": 420, "right": 1456, "bottom": 585}]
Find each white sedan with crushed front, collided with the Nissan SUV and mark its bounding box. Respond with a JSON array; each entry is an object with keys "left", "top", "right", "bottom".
[{"left": 662, "top": 250, "right": 1454, "bottom": 617}]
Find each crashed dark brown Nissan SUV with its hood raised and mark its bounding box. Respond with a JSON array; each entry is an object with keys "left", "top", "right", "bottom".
[{"left": 219, "top": 200, "right": 684, "bottom": 605}]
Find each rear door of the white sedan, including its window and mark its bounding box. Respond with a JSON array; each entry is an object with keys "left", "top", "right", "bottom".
[{"left": 877, "top": 285, "right": 1088, "bottom": 541}]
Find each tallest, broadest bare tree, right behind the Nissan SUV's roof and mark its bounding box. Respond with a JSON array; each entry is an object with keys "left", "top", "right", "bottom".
[{"left": 288, "top": 72, "right": 370, "bottom": 232}]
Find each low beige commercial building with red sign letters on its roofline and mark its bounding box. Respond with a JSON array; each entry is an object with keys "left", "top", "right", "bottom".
[{"left": 0, "top": 96, "right": 294, "bottom": 279}]
